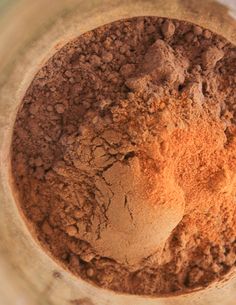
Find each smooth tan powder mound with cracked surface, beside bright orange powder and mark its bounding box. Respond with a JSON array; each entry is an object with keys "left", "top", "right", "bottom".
[{"left": 74, "top": 129, "right": 184, "bottom": 268}]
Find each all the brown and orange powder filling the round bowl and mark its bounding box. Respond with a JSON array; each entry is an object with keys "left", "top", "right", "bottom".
[{"left": 12, "top": 17, "right": 236, "bottom": 295}]
